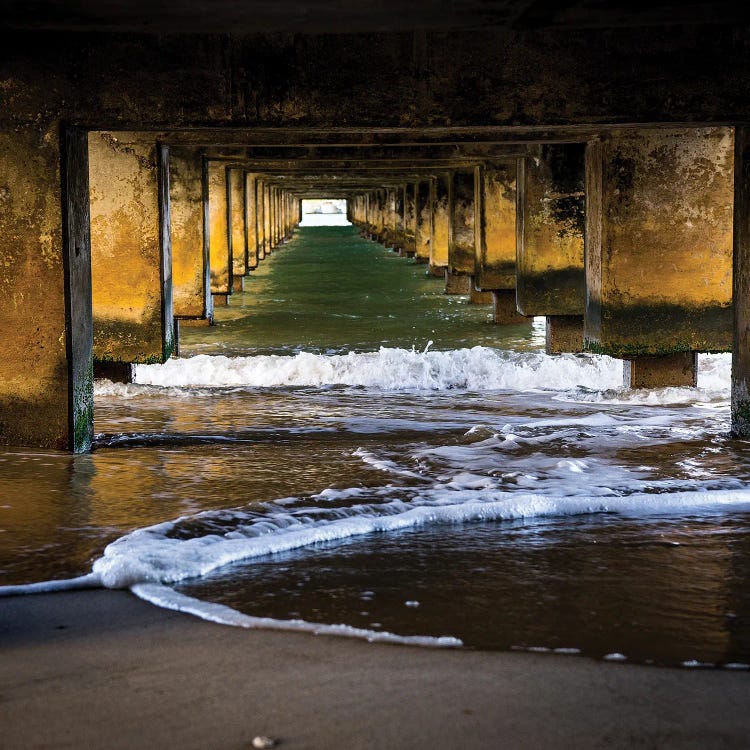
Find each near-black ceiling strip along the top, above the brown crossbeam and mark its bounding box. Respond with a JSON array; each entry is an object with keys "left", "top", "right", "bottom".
[{"left": 0, "top": 0, "right": 750, "bottom": 34}]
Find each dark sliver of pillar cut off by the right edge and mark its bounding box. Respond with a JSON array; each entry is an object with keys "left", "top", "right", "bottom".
[{"left": 732, "top": 126, "right": 750, "bottom": 438}]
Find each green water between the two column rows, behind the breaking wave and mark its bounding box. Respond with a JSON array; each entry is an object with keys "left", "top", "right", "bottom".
[{"left": 181, "top": 227, "right": 543, "bottom": 355}]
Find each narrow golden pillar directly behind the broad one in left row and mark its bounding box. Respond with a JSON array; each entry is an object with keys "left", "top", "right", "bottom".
[{"left": 169, "top": 146, "right": 213, "bottom": 322}]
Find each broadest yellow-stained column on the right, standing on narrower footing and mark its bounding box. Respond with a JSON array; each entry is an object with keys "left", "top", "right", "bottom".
[{"left": 585, "top": 127, "right": 741, "bottom": 386}]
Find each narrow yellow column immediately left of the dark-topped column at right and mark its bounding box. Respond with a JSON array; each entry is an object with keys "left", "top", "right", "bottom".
[{"left": 474, "top": 159, "right": 518, "bottom": 289}]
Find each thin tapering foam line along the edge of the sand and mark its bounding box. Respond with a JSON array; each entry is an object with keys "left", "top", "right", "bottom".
[{"left": 132, "top": 583, "right": 463, "bottom": 648}]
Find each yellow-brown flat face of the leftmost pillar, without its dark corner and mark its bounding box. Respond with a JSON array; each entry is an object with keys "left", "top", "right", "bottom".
[{"left": 0, "top": 125, "right": 71, "bottom": 449}]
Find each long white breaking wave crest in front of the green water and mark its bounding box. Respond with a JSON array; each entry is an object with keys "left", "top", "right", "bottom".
[{"left": 135, "top": 346, "right": 622, "bottom": 391}]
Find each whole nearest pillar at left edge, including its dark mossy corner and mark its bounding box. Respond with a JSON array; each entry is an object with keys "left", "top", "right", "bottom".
[{"left": 0, "top": 127, "right": 94, "bottom": 451}]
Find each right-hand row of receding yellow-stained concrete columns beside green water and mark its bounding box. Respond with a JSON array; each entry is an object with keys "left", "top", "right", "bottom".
[{"left": 351, "top": 127, "right": 735, "bottom": 394}]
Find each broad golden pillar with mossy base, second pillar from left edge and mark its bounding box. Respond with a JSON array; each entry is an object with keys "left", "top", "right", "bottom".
[{"left": 89, "top": 131, "right": 175, "bottom": 370}]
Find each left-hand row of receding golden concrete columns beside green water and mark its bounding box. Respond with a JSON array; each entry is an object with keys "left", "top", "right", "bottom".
[{"left": 88, "top": 136, "right": 300, "bottom": 380}]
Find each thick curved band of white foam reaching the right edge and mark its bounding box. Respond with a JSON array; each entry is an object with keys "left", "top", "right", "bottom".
[{"left": 93, "top": 488, "right": 750, "bottom": 588}]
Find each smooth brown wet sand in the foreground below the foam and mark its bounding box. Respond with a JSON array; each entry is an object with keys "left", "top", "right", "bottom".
[{"left": 0, "top": 590, "right": 750, "bottom": 750}]
